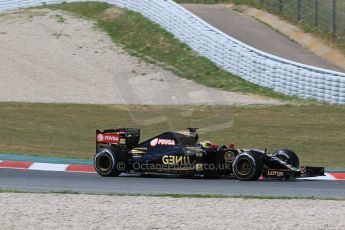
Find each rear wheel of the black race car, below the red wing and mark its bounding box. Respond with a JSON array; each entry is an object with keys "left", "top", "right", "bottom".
[{"left": 94, "top": 148, "right": 126, "bottom": 177}]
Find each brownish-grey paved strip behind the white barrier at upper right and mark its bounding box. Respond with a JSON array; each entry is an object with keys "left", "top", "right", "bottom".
[{"left": 182, "top": 4, "right": 344, "bottom": 72}]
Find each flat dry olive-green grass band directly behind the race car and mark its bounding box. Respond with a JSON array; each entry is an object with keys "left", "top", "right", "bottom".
[{"left": 0, "top": 103, "right": 345, "bottom": 167}]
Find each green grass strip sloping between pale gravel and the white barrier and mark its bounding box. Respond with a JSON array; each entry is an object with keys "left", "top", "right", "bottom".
[{"left": 38, "top": 2, "right": 298, "bottom": 100}]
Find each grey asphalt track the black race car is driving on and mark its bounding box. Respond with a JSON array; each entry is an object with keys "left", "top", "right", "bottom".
[{"left": 0, "top": 169, "right": 345, "bottom": 199}]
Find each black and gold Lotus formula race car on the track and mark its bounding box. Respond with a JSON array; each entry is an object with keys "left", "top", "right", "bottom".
[{"left": 94, "top": 128, "right": 324, "bottom": 181}]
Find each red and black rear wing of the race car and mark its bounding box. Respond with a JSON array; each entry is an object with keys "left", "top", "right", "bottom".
[{"left": 96, "top": 128, "right": 140, "bottom": 151}]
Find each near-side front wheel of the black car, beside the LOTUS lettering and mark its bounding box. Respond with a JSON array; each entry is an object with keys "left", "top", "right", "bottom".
[{"left": 232, "top": 152, "right": 263, "bottom": 181}]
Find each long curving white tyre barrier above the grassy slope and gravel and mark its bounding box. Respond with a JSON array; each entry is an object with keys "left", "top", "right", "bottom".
[{"left": 0, "top": 0, "right": 345, "bottom": 104}]
